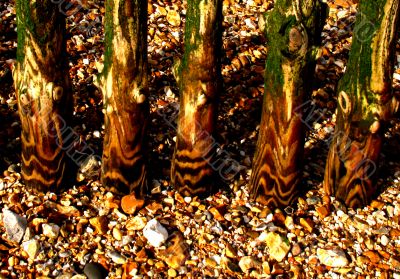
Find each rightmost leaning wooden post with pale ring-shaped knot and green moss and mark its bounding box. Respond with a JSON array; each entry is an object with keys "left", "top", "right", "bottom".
[{"left": 323, "top": 0, "right": 399, "bottom": 207}]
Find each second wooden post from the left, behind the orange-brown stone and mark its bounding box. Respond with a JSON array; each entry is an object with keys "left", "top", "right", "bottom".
[{"left": 100, "top": 0, "right": 149, "bottom": 196}]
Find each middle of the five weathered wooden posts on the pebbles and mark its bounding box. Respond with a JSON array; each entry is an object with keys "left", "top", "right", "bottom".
[{"left": 171, "top": 0, "right": 222, "bottom": 195}]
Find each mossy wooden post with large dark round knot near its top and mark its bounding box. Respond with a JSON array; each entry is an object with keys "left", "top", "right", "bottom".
[{"left": 249, "top": 0, "right": 325, "bottom": 207}]
